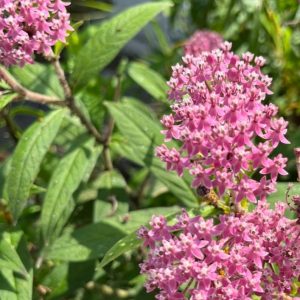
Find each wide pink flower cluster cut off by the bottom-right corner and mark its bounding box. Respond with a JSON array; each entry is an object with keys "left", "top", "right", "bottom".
[{"left": 138, "top": 202, "right": 300, "bottom": 300}]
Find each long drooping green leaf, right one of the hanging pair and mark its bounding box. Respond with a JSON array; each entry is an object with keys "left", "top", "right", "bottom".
[{"left": 41, "top": 139, "right": 94, "bottom": 242}]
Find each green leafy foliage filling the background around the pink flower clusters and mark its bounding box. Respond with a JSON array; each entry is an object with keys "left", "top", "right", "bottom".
[{"left": 0, "top": 0, "right": 300, "bottom": 300}]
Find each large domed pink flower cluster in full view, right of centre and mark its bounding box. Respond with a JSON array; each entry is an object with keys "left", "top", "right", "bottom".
[{"left": 156, "top": 42, "right": 289, "bottom": 202}]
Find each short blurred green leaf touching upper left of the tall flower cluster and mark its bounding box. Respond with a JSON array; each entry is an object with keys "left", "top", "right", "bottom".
[{"left": 128, "top": 63, "right": 168, "bottom": 102}]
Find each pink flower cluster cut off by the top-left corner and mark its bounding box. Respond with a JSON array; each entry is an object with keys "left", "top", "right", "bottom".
[{"left": 0, "top": 0, "right": 72, "bottom": 66}]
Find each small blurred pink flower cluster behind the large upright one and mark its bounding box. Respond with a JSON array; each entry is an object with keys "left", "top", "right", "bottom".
[{"left": 184, "top": 30, "right": 223, "bottom": 56}]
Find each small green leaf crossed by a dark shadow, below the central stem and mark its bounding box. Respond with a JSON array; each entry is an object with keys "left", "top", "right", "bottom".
[{"left": 93, "top": 170, "right": 129, "bottom": 222}]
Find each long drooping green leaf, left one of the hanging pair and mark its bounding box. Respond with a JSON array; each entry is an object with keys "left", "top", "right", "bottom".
[{"left": 4, "top": 110, "right": 65, "bottom": 221}]
